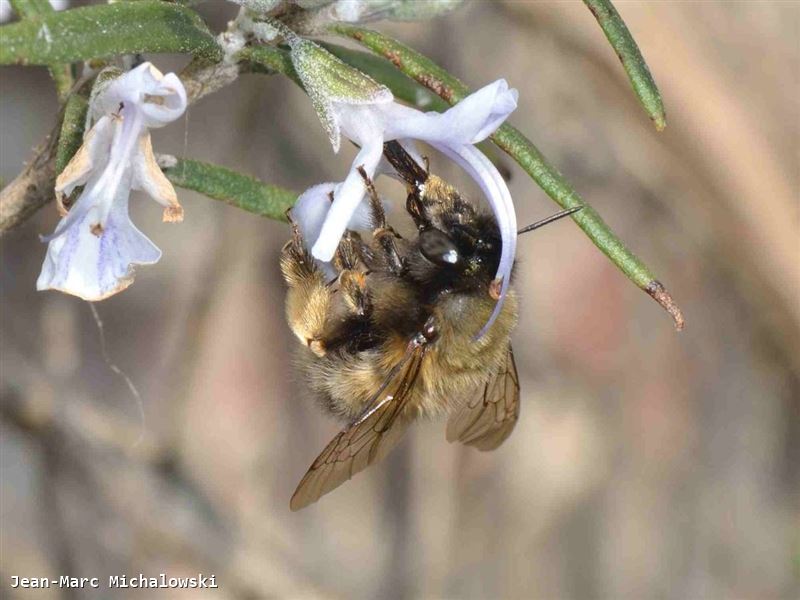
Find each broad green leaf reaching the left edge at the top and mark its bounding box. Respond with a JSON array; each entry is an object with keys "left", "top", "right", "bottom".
[{"left": 0, "top": 0, "right": 222, "bottom": 65}]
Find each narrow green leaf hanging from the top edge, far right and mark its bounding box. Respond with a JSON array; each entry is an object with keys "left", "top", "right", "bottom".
[{"left": 583, "top": 0, "right": 667, "bottom": 131}]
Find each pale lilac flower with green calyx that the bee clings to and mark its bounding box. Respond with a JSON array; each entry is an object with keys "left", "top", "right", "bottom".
[{"left": 289, "top": 38, "right": 517, "bottom": 335}]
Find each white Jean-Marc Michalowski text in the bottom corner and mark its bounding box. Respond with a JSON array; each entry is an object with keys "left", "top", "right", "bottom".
[{"left": 11, "top": 573, "right": 219, "bottom": 589}]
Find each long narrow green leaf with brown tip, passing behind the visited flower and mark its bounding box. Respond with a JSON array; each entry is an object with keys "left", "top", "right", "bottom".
[{"left": 331, "top": 24, "right": 683, "bottom": 329}]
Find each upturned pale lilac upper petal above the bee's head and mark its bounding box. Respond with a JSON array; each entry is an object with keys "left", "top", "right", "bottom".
[{"left": 384, "top": 79, "right": 518, "bottom": 146}]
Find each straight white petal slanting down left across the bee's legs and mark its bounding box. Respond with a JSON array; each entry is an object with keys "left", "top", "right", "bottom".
[{"left": 311, "top": 137, "right": 383, "bottom": 262}]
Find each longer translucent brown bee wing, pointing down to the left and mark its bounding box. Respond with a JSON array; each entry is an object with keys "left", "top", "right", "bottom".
[{"left": 289, "top": 345, "right": 426, "bottom": 511}]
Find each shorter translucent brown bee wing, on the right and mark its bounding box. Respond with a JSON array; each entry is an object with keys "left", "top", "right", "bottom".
[{"left": 447, "top": 345, "right": 519, "bottom": 451}]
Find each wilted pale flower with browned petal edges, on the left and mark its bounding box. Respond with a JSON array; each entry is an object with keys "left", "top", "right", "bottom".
[{"left": 36, "top": 63, "right": 186, "bottom": 301}]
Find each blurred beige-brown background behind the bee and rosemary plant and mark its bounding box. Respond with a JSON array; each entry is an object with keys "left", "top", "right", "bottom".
[{"left": 0, "top": 0, "right": 800, "bottom": 599}]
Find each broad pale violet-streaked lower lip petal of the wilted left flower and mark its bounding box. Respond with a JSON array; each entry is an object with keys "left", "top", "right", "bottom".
[{"left": 36, "top": 190, "right": 161, "bottom": 301}]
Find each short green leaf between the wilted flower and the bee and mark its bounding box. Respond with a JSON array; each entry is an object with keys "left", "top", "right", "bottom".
[{"left": 163, "top": 159, "right": 297, "bottom": 222}]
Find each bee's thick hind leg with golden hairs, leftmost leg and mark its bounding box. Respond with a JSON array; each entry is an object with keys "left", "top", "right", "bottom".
[{"left": 280, "top": 215, "right": 331, "bottom": 356}]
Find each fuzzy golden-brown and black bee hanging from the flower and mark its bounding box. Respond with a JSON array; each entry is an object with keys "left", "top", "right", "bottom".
[{"left": 280, "top": 142, "right": 574, "bottom": 511}]
